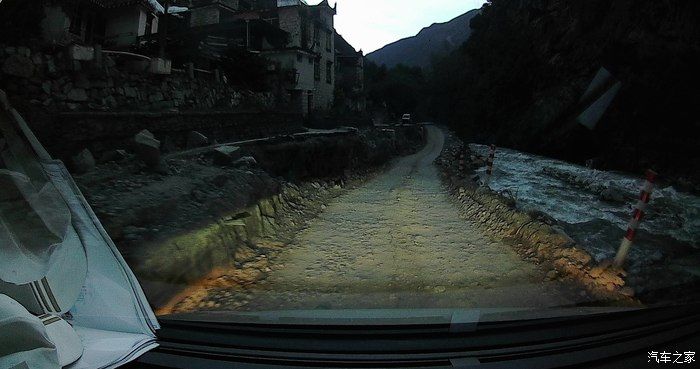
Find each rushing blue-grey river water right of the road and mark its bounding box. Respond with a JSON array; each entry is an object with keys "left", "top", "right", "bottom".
[{"left": 470, "top": 144, "right": 700, "bottom": 264}]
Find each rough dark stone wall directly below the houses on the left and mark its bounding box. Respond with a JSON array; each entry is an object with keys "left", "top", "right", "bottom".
[{"left": 0, "top": 45, "right": 274, "bottom": 113}]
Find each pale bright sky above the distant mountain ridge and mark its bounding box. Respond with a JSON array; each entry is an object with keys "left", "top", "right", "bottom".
[{"left": 307, "top": 0, "right": 485, "bottom": 54}]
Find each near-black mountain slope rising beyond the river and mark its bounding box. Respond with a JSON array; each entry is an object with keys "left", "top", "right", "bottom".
[{"left": 432, "top": 0, "right": 700, "bottom": 188}]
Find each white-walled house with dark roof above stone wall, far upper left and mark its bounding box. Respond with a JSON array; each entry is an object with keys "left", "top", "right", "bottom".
[{"left": 41, "top": 0, "right": 163, "bottom": 48}]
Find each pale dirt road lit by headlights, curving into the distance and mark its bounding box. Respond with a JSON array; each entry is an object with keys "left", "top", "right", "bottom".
[{"left": 226, "top": 127, "right": 570, "bottom": 311}]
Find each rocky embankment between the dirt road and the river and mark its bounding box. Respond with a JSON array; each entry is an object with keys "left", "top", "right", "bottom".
[{"left": 437, "top": 129, "right": 639, "bottom": 305}]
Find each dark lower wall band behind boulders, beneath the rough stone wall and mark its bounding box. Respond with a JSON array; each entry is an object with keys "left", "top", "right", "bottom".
[{"left": 36, "top": 111, "right": 303, "bottom": 158}]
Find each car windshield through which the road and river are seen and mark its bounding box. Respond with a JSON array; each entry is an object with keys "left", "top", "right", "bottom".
[{"left": 0, "top": 0, "right": 700, "bottom": 330}]
